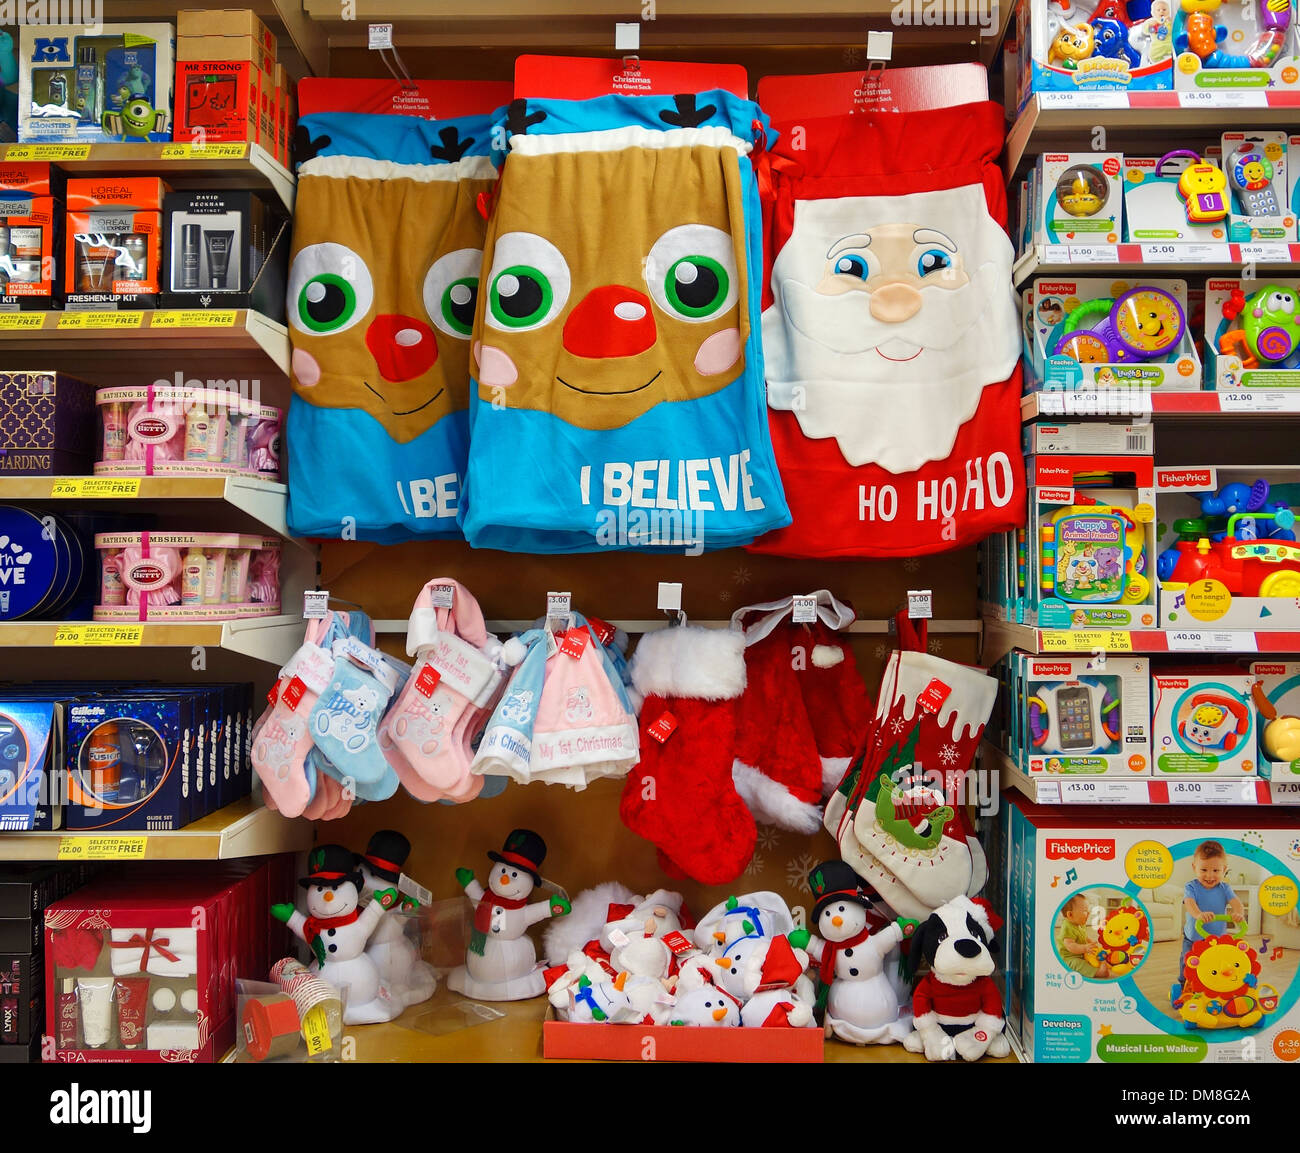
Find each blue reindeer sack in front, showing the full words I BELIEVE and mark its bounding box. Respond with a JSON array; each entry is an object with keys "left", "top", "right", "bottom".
[{"left": 462, "top": 91, "right": 789, "bottom": 552}]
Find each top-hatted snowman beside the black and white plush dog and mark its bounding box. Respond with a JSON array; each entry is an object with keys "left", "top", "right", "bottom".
[{"left": 807, "top": 861, "right": 917, "bottom": 1045}]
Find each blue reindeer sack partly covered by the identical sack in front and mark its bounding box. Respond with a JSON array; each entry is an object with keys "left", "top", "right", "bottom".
[{"left": 286, "top": 112, "right": 497, "bottom": 541}]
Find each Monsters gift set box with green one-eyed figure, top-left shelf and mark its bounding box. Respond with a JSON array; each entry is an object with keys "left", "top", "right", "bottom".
[{"left": 18, "top": 23, "right": 176, "bottom": 143}]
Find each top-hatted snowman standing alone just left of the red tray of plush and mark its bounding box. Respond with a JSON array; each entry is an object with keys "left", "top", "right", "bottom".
[{"left": 447, "top": 829, "right": 572, "bottom": 1001}]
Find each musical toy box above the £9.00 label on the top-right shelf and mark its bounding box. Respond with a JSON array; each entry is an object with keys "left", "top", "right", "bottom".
[{"left": 1015, "top": 0, "right": 1174, "bottom": 108}]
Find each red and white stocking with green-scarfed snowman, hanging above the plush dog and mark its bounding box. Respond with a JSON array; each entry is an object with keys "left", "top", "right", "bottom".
[{"left": 824, "top": 616, "right": 997, "bottom": 919}]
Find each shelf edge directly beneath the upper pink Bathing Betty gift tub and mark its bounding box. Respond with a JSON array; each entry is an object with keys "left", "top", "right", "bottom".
[{"left": 0, "top": 476, "right": 289, "bottom": 537}]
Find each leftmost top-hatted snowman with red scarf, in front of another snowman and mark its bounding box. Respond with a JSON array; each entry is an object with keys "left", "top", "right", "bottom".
[{"left": 270, "top": 845, "right": 402, "bottom": 1024}]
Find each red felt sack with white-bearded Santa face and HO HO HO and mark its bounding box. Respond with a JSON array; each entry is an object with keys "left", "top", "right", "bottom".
[{"left": 753, "top": 103, "right": 1024, "bottom": 556}]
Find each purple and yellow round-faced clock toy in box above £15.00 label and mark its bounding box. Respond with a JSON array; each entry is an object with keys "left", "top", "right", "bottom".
[{"left": 1052, "top": 286, "right": 1187, "bottom": 364}]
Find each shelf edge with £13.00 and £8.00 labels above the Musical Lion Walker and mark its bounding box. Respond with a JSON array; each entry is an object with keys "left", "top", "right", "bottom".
[{"left": 980, "top": 741, "right": 1300, "bottom": 805}]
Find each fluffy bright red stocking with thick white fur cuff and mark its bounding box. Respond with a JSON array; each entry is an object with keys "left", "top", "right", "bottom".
[{"left": 619, "top": 627, "right": 758, "bottom": 885}]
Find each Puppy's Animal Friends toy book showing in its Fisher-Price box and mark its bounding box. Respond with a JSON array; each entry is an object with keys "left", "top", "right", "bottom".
[{"left": 1039, "top": 504, "right": 1151, "bottom": 604}]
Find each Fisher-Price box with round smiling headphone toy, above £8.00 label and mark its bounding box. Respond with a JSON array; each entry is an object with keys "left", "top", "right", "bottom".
[{"left": 1151, "top": 667, "right": 1258, "bottom": 777}]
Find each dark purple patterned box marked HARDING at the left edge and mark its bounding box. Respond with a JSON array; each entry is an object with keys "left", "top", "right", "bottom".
[{"left": 0, "top": 370, "right": 95, "bottom": 476}]
